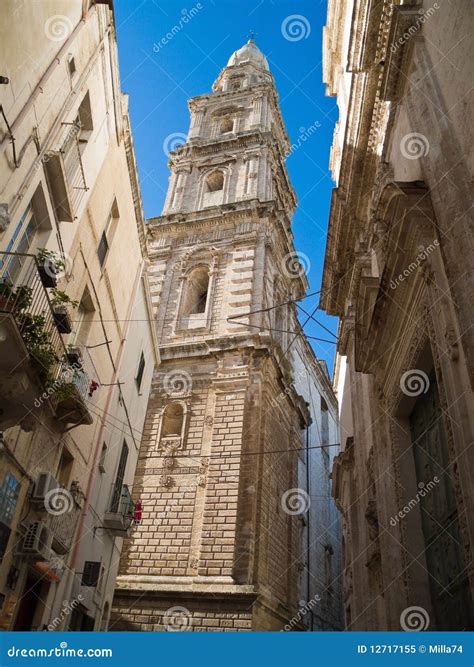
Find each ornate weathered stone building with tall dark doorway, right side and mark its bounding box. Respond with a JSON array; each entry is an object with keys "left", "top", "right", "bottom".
[{"left": 323, "top": 0, "right": 474, "bottom": 630}]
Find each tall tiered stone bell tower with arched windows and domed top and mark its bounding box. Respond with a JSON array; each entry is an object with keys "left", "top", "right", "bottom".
[{"left": 110, "top": 40, "right": 309, "bottom": 631}]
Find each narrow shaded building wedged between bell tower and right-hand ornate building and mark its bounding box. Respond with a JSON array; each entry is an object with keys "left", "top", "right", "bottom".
[{"left": 292, "top": 336, "right": 343, "bottom": 631}]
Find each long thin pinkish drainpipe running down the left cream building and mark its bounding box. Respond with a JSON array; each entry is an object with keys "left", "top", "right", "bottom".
[{"left": 59, "top": 254, "right": 145, "bottom": 620}]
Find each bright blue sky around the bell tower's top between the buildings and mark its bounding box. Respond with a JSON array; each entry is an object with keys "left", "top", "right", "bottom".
[{"left": 115, "top": 0, "right": 338, "bottom": 374}]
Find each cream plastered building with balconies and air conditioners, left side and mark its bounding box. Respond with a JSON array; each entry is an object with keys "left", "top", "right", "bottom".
[{"left": 0, "top": 0, "right": 159, "bottom": 630}]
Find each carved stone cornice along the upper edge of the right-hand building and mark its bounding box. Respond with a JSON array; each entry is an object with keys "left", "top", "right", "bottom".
[{"left": 323, "top": 0, "right": 418, "bottom": 316}]
